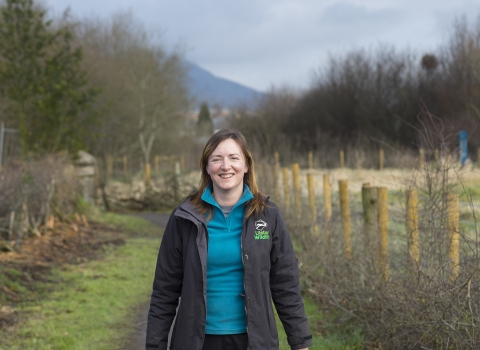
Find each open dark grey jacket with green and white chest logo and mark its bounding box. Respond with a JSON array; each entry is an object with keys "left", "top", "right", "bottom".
[{"left": 146, "top": 200, "right": 312, "bottom": 350}]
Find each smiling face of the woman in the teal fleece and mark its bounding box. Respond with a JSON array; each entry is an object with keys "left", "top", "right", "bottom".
[{"left": 207, "top": 139, "right": 248, "bottom": 198}]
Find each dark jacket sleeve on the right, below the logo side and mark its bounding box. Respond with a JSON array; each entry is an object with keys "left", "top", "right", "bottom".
[{"left": 270, "top": 208, "right": 313, "bottom": 350}]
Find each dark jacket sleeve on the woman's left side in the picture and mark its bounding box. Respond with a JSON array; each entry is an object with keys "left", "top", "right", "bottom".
[{"left": 146, "top": 210, "right": 183, "bottom": 350}]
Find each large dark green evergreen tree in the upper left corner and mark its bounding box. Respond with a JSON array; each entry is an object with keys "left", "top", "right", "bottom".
[{"left": 0, "top": 0, "right": 98, "bottom": 154}]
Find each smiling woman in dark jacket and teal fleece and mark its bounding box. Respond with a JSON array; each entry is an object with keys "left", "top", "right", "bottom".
[{"left": 146, "top": 130, "right": 312, "bottom": 350}]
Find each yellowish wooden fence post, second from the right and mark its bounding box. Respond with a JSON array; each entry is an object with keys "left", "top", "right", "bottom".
[{"left": 406, "top": 190, "right": 420, "bottom": 272}]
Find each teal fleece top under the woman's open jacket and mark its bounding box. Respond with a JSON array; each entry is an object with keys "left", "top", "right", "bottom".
[{"left": 202, "top": 184, "right": 253, "bottom": 334}]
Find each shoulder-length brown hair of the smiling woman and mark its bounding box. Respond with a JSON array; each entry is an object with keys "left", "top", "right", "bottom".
[{"left": 188, "top": 129, "right": 265, "bottom": 217}]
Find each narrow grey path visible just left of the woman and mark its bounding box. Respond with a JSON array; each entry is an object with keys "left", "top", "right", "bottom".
[{"left": 122, "top": 212, "right": 170, "bottom": 350}]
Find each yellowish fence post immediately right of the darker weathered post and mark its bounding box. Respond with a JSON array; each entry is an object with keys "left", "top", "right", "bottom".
[{"left": 377, "top": 187, "right": 390, "bottom": 281}]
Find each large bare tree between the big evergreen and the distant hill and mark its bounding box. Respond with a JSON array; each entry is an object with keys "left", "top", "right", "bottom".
[{"left": 78, "top": 13, "right": 189, "bottom": 162}]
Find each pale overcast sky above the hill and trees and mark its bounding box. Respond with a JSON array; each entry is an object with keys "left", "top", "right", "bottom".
[{"left": 44, "top": 0, "right": 480, "bottom": 91}]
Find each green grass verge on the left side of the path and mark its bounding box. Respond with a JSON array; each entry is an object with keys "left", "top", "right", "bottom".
[{"left": 0, "top": 238, "right": 160, "bottom": 350}]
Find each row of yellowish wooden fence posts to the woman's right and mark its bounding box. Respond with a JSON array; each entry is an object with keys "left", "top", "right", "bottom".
[{"left": 273, "top": 153, "right": 460, "bottom": 280}]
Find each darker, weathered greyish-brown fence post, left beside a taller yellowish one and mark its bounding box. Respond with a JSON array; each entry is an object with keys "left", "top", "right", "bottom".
[{"left": 362, "top": 183, "right": 378, "bottom": 264}]
